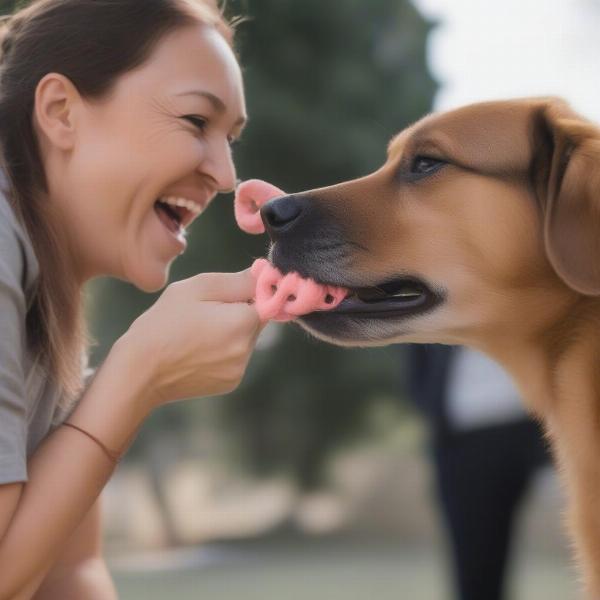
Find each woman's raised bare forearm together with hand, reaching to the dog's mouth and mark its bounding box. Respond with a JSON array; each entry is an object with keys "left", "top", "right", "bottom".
[{"left": 0, "top": 272, "right": 261, "bottom": 600}]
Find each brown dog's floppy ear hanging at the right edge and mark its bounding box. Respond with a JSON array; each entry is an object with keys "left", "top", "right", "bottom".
[{"left": 532, "top": 100, "right": 600, "bottom": 296}]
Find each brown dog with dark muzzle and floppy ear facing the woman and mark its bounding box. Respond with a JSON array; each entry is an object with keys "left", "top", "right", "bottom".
[{"left": 262, "top": 99, "right": 600, "bottom": 599}]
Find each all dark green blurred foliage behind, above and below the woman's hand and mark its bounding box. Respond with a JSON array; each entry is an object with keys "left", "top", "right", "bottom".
[{"left": 8, "top": 0, "right": 436, "bottom": 487}]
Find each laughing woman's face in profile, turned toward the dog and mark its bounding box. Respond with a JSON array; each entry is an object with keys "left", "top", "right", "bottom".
[{"left": 48, "top": 24, "right": 246, "bottom": 291}]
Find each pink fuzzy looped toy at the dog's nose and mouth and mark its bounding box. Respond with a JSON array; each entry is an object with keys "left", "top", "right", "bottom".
[{"left": 234, "top": 179, "right": 348, "bottom": 321}]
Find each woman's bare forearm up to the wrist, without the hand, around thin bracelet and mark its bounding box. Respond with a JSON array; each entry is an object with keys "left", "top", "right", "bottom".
[{"left": 0, "top": 344, "right": 148, "bottom": 600}]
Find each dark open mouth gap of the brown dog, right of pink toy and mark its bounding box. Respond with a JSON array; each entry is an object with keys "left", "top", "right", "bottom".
[{"left": 330, "top": 277, "right": 434, "bottom": 318}]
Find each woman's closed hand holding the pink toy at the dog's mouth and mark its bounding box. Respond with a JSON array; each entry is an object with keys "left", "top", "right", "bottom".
[{"left": 117, "top": 269, "right": 263, "bottom": 407}]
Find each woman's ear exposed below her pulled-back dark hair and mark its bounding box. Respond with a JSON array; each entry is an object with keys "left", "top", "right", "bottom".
[{"left": 33, "top": 73, "right": 81, "bottom": 150}]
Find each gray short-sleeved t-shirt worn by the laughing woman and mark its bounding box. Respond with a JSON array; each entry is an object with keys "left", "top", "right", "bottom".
[{"left": 0, "top": 182, "right": 63, "bottom": 484}]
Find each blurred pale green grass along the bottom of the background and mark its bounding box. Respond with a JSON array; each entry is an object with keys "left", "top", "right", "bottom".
[{"left": 112, "top": 539, "right": 577, "bottom": 600}]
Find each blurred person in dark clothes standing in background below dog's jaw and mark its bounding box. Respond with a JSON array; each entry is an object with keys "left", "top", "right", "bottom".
[{"left": 407, "top": 344, "right": 549, "bottom": 600}]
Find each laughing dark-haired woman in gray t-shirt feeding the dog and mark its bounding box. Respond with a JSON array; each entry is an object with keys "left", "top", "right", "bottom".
[{"left": 0, "top": 0, "right": 260, "bottom": 599}]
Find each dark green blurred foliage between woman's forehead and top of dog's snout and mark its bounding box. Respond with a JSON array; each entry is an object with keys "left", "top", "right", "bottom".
[{"left": 233, "top": 0, "right": 435, "bottom": 191}]
